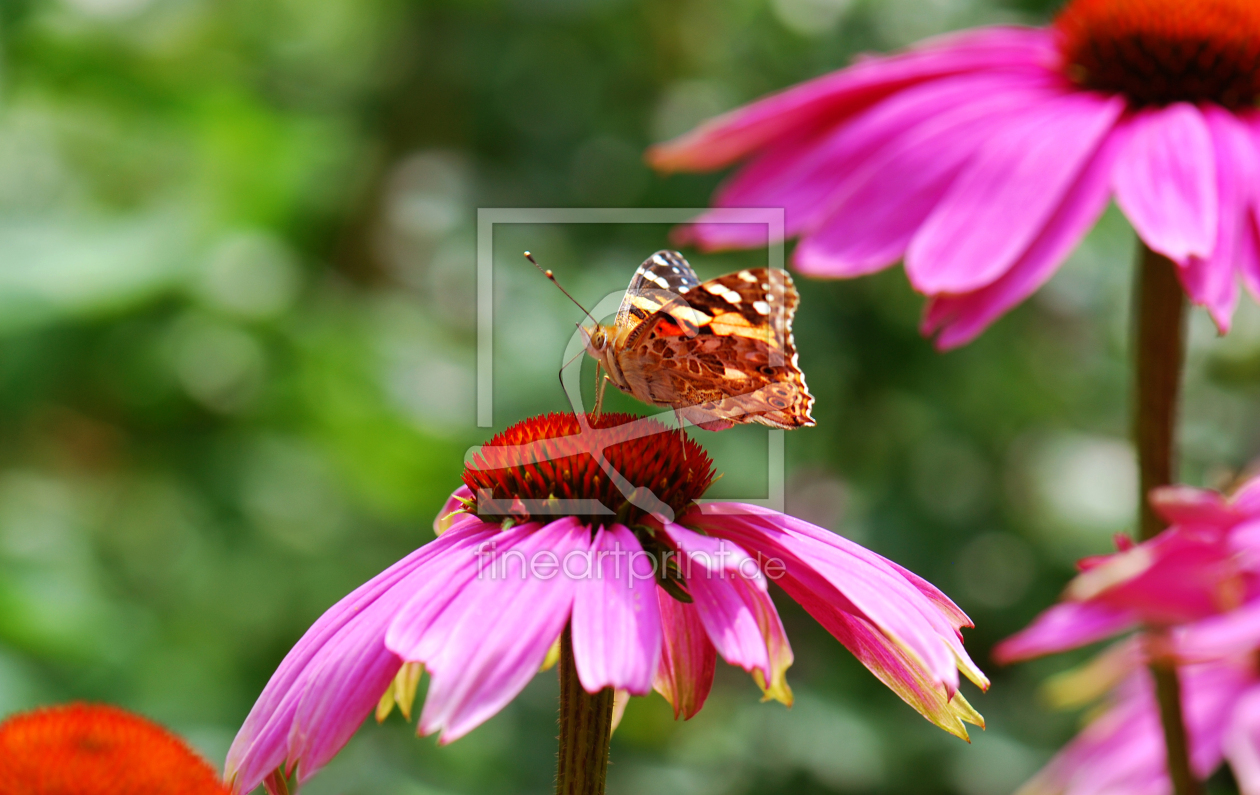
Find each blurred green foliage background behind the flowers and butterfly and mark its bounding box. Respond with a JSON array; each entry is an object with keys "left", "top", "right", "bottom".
[{"left": 0, "top": 0, "right": 1260, "bottom": 795}]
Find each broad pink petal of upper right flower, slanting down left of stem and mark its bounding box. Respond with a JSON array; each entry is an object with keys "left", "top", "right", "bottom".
[{"left": 906, "top": 93, "right": 1124, "bottom": 295}]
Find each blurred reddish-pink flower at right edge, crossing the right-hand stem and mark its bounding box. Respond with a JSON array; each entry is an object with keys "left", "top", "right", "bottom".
[{"left": 993, "top": 478, "right": 1260, "bottom": 663}]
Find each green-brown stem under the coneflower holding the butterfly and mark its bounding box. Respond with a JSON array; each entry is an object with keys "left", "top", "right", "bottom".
[{"left": 556, "top": 627, "right": 612, "bottom": 795}]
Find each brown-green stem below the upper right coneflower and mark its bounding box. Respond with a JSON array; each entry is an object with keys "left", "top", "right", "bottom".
[{"left": 1133, "top": 242, "right": 1201, "bottom": 795}]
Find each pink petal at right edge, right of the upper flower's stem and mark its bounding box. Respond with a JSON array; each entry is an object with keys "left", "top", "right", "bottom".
[{"left": 1179, "top": 106, "right": 1260, "bottom": 334}]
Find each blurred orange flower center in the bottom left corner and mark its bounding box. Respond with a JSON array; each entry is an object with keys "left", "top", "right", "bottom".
[{"left": 0, "top": 704, "right": 229, "bottom": 795}]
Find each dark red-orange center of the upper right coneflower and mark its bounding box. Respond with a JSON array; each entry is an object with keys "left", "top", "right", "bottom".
[{"left": 1055, "top": 0, "right": 1260, "bottom": 110}]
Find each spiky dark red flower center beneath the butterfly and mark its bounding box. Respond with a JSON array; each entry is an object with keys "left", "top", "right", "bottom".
[{"left": 464, "top": 413, "right": 713, "bottom": 524}]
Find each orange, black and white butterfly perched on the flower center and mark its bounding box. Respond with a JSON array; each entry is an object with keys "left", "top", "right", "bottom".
[{"left": 582, "top": 251, "right": 814, "bottom": 431}]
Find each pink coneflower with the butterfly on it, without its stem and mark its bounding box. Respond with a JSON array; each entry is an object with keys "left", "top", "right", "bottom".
[{"left": 227, "top": 415, "right": 988, "bottom": 792}]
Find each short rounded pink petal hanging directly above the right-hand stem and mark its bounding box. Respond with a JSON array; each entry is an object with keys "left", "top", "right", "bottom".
[{"left": 1114, "top": 102, "right": 1220, "bottom": 262}]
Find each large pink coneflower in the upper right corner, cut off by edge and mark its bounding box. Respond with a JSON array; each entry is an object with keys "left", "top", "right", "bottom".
[{"left": 649, "top": 0, "right": 1260, "bottom": 349}]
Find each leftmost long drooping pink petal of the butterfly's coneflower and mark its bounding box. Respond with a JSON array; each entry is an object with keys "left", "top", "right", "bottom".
[{"left": 224, "top": 524, "right": 499, "bottom": 792}]
